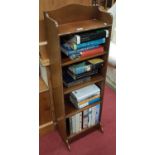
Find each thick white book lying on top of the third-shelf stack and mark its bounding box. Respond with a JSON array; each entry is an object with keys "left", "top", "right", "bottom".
[{"left": 70, "top": 84, "right": 100, "bottom": 103}]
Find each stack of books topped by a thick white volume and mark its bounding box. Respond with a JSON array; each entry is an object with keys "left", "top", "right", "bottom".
[{"left": 69, "top": 84, "right": 101, "bottom": 109}]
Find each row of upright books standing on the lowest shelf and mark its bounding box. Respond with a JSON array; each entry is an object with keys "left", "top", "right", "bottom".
[{"left": 69, "top": 104, "right": 100, "bottom": 134}]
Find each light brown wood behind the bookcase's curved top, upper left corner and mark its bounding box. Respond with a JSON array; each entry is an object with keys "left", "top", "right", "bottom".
[{"left": 39, "top": 0, "right": 92, "bottom": 20}]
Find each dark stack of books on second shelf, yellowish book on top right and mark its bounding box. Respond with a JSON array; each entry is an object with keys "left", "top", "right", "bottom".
[{"left": 63, "top": 58, "right": 104, "bottom": 87}]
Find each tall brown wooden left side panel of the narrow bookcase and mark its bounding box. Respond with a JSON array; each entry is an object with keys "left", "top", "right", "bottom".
[{"left": 45, "top": 14, "right": 66, "bottom": 140}]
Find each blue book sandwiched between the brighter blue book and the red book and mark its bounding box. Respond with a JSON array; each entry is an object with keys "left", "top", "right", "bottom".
[{"left": 60, "top": 43, "right": 99, "bottom": 56}]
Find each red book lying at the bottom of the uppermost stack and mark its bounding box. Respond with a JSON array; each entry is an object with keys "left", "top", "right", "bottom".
[{"left": 81, "top": 46, "right": 104, "bottom": 58}]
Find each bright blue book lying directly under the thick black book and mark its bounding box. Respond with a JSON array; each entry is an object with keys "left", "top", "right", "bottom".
[{"left": 71, "top": 38, "right": 105, "bottom": 50}]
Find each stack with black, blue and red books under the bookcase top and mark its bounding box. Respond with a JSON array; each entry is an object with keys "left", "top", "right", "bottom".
[{"left": 61, "top": 29, "right": 109, "bottom": 59}]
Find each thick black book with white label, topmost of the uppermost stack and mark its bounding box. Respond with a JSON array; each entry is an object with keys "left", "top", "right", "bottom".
[{"left": 70, "top": 29, "right": 109, "bottom": 44}]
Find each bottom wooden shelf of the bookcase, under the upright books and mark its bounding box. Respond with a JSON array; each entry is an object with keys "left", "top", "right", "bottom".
[{"left": 67, "top": 123, "right": 100, "bottom": 142}]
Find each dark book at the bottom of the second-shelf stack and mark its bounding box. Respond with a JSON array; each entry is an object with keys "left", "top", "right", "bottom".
[{"left": 63, "top": 71, "right": 91, "bottom": 87}]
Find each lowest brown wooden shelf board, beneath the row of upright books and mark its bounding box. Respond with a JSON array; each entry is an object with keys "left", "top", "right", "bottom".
[{"left": 67, "top": 123, "right": 99, "bottom": 140}]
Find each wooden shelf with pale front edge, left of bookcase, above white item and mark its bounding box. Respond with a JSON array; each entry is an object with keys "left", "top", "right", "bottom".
[{"left": 39, "top": 46, "right": 50, "bottom": 66}]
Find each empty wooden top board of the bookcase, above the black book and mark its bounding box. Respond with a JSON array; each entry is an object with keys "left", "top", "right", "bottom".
[{"left": 58, "top": 19, "right": 111, "bottom": 36}]
